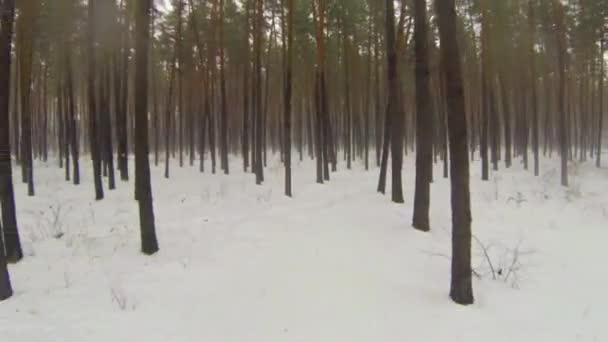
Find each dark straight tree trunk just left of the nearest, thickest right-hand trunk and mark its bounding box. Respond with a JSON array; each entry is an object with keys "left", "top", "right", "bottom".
[{"left": 412, "top": 0, "right": 433, "bottom": 231}]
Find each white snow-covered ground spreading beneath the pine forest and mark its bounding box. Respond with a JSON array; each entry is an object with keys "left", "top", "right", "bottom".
[{"left": 0, "top": 156, "right": 608, "bottom": 342}]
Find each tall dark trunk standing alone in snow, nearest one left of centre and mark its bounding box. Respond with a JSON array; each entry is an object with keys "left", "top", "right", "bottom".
[{"left": 135, "top": 0, "right": 158, "bottom": 255}]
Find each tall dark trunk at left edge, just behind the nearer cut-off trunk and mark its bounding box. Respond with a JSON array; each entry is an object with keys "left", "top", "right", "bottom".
[{"left": 0, "top": 0, "right": 23, "bottom": 262}]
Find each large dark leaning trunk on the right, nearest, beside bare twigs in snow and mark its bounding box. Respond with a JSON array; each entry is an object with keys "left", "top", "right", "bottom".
[{"left": 435, "top": 0, "right": 474, "bottom": 305}]
